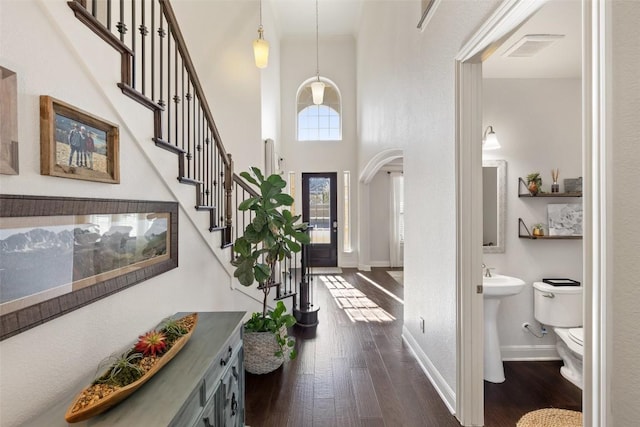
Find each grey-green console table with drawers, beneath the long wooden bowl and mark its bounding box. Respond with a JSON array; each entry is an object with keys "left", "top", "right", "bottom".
[{"left": 26, "top": 312, "right": 245, "bottom": 427}]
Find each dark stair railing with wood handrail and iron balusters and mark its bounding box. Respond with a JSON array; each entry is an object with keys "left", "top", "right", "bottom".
[{"left": 67, "top": 0, "right": 309, "bottom": 310}]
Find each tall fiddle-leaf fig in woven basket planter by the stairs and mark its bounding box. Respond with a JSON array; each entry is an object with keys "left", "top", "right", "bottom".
[{"left": 231, "top": 167, "right": 309, "bottom": 374}]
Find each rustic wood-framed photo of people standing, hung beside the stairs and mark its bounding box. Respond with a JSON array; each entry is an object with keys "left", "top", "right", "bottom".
[{"left": 40, "top": 95, "right": 120, "bottom": 184}]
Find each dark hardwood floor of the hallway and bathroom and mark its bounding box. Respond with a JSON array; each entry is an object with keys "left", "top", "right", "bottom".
[{"left": 245, "top": 268, "right": 580, "bottom": 427}]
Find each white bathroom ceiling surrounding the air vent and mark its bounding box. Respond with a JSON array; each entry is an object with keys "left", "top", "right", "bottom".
[{"left": 482, "top": 0, "right": 582, "bottom": 78}]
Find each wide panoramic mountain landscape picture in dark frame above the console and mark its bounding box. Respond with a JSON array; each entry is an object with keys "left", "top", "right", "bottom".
[{"left": 0, "top": 195, "right": 178, "bottom": 340}]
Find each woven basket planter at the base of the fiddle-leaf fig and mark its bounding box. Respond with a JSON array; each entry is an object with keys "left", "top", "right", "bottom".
[{"left": 243, "top": 329, "right": 286, "bottom": 374}]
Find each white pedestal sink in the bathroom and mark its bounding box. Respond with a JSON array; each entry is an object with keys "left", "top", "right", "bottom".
[{"left": 482, "top": 274, "right": 524, "bottom": 383}]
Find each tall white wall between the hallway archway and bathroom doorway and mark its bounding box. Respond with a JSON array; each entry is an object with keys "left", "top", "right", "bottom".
[{"left": 357, "top": 1, "right": 498, "bottom": 408}]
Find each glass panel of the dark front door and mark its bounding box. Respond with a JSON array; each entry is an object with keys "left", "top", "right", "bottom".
[{"left": 309, "top": 177, "right": 331, "bottom": 244}]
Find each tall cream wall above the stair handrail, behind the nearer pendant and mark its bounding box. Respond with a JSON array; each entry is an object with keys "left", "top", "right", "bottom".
[{"left": 171, "top": 0, "right": 264, "bottom": 173}]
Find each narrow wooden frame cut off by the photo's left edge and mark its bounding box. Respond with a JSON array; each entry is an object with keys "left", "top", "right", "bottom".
[{"left": 0, "top": 67, "right": 18, "bottom": 175}]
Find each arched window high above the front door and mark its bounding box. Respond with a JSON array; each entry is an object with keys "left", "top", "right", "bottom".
[{"left": 297, "top": 79, "right": 342, "bottom": 141}]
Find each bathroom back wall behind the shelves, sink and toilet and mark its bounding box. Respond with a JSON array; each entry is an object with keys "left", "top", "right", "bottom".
[{"left": 483, "top": 79, "right": 582, "bottom": 359}]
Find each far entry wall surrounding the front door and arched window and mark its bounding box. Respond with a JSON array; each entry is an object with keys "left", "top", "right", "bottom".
[{"left": 280, "top": 36, "right": 358, "bottom": 267}]
